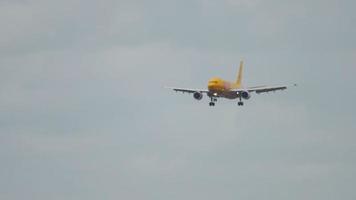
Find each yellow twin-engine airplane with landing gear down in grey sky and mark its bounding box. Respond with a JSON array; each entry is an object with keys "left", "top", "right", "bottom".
[{"left": 167, "top": 61, "right": 297, "bottom": 106}]
